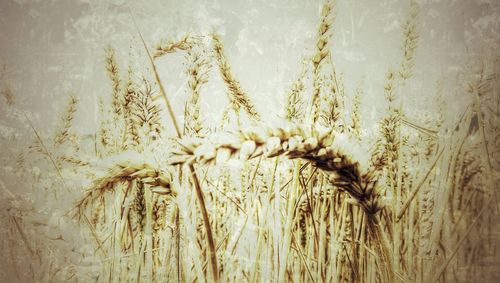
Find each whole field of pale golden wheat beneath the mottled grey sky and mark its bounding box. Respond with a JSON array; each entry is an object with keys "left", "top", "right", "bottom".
[{"left": 0, "top": 0, "right": 500, "bottom": 282}]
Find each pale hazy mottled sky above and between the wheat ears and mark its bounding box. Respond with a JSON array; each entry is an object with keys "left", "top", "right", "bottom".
[{"left": 0, "top": 0, "right": 500, "bottom": 282}]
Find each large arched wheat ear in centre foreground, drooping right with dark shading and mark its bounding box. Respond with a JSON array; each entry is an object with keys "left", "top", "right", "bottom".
[{"left": 169, "top": 125, "right": 393, "bottom": 281}]
